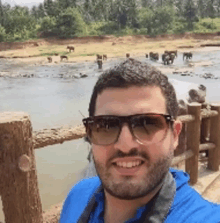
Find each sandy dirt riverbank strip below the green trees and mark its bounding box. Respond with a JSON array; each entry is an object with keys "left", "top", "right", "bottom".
[{"left": 0, "top": 34, "right": 220, "bottom": 65}]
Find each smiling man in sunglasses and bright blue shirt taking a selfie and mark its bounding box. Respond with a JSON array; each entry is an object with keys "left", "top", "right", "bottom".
[{"left": 60, "top": 59, "right": 220, "bottom": 223}]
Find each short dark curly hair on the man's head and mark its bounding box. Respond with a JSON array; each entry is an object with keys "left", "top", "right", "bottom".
[{"left": 89, "top": 58, "right": 178, "bottom": 118}]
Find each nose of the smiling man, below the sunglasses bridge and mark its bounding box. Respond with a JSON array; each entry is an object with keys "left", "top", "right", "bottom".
[{"left": 114, "top": 123, "right": 139, "bottom": 153}]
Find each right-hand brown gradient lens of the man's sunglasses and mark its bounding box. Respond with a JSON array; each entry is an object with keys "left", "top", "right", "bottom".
[{"left": 131, "top": 114, "right": 168, "bottom": 144}]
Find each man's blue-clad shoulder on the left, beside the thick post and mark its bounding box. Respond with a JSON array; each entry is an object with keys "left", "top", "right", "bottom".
[{"left": 60, "top": 176, "right": 101, "bottom": 223}]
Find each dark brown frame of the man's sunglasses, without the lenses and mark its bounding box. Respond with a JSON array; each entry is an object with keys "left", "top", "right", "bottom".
[{"left": 82, "top": 113, "right": 175, "bottom": 146}]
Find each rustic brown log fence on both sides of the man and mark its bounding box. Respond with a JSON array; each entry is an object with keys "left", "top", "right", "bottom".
[{"left": 0, "top": 103, "right": 220, "bottom": 223}]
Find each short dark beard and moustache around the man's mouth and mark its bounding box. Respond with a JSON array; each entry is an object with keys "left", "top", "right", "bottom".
[{"left": 94, "top": 148, "right": 173, "bottom": 200}]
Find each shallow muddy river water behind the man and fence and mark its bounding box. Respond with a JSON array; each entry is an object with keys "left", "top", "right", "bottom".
[{"left": 0, "top": 49, "right": 220, "bottom": 220}]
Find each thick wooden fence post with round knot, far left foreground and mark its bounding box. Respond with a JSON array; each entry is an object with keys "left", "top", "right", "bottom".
[{"left": 0, "top": 112, "right": 43, "bottom": 223}]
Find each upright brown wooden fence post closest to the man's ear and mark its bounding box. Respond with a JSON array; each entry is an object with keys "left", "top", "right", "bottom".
[{"left": 186, "top": 103, "right": 201, "bottom": 185}]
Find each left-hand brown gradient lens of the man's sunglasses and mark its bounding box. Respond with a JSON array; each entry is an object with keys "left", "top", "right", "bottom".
[{"left": 87, "top": 117, "right": 120, "bottom": 145}]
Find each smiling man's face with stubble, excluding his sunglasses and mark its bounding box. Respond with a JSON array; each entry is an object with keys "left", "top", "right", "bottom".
[{"left": 92, "top": 87, "right": 181, "bottom": 200}]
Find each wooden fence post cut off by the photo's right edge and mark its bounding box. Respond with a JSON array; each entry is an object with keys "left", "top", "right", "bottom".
[{"left": 208, "top": 104, "right": 220, "bottom": 171}]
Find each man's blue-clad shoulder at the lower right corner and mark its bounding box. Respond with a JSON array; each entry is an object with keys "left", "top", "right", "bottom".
[{"left": 166, "top": 170, "right": 220, "bottom": 223}]
